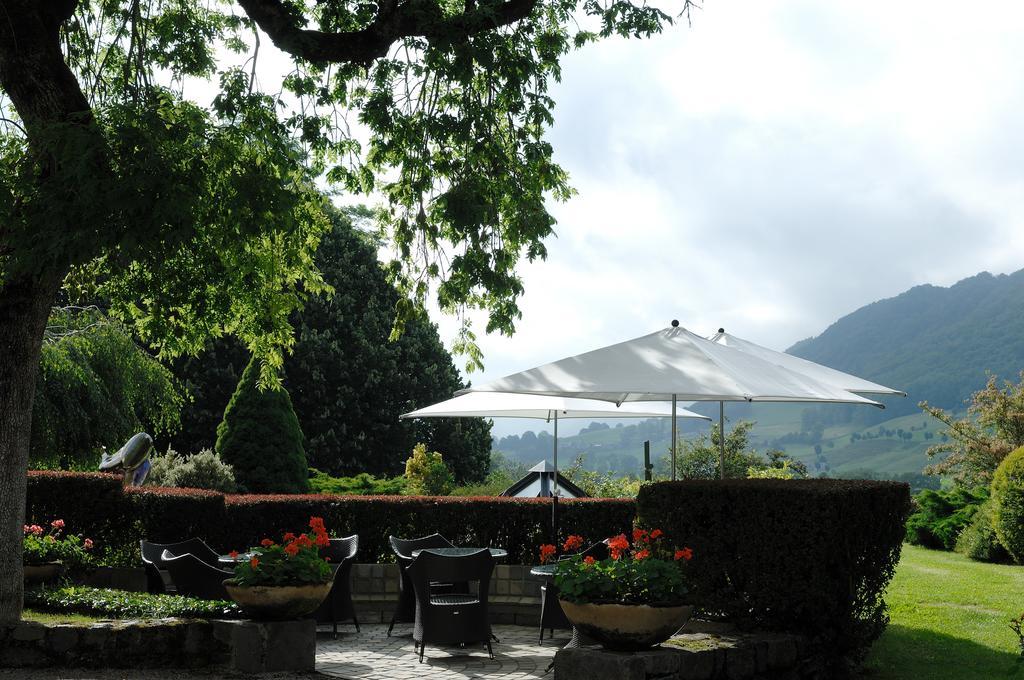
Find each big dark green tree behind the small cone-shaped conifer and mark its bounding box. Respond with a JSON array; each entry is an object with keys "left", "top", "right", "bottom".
[{"left": 171, "top": 210, "right": 490, "bottom": 483}]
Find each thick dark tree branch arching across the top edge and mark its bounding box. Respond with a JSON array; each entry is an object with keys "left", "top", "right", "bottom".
[{"left": 239, "top": 0, "right": 539, "bottom": 63}]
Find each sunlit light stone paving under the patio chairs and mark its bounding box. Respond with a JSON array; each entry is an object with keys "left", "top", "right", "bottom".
[{"left": 316, "top": 624, "right": 568, "bottom": 680}]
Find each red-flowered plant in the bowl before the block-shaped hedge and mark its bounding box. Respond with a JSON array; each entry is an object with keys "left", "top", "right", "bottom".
[{"left": 541, "top": 528, "right": 693, "bottom": 606}]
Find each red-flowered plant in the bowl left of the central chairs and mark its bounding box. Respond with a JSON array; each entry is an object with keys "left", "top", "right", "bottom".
[{"left": 231, "top": 517, "right": 332, "bottom": 586}]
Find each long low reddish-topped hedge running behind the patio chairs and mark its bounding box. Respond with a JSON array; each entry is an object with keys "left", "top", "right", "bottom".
[{"left": 28, "top": 472, "right": 636, "bottom": 565}]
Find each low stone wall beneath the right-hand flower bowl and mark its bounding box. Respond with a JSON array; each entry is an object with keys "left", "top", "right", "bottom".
[{"left": 554, "top": 622, "right": 807, "bottom": 680}]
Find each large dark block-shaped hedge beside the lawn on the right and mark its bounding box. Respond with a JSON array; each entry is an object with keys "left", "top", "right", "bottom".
[{"left": 637, "top": 479, "right": 910, "bottom": 674}]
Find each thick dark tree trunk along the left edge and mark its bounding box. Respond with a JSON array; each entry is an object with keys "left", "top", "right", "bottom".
[{"left": 0, "top": 0, "right": 94, "bottom": 625}]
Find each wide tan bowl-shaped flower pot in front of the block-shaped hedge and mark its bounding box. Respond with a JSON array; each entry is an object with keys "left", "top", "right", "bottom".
[{"left": 558, "top": 599, "right": 693, "bottom": 651}]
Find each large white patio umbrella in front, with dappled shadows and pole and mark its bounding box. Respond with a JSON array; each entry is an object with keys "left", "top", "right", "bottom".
[{"left": 465, "top": 321, "right": 885, "bottom": 479}]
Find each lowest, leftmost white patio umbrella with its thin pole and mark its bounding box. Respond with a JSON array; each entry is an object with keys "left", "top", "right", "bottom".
[{"left": 399, "top": 391, "right": 711, "bottom": 534}]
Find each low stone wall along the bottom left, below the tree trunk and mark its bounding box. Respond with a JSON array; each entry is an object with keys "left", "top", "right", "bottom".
[{"left": 0, "top": 619, "right": 316, "bottom": 673}]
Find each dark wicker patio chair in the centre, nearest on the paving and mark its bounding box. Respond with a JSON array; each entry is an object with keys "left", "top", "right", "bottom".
[{"left": 407, "top": 548, "right": 495, "bottom": 664}]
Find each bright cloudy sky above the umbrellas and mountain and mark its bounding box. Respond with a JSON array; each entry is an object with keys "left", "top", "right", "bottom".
[{"left": 430, "top": 0, "right": 1024, "bottom": 436}]
